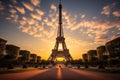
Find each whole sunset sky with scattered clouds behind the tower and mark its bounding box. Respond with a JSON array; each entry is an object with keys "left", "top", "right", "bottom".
[{"left": 0, "top": 0, "right": 120, "bottom": 59}]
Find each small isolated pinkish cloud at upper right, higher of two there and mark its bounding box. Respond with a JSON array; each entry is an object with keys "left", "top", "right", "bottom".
[{"left": 101, "top": 3, "right": 116, "bottom": 16}]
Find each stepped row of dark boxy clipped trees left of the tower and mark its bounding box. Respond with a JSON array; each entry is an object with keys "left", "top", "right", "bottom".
[{"left": 0, "top": 38, "right": 41, "bottom": 65}]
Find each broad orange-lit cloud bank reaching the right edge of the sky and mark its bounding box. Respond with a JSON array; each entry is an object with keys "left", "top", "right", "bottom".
[{"left": 66, "top": 17, "right": 120, "bottom": 44}]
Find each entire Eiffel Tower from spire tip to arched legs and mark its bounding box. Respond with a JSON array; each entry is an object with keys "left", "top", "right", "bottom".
[{"left": 48, "top": 0, "right": 73, "bottom": 62}]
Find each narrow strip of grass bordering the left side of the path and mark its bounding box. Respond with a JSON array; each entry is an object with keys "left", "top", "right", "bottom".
[{"left": 0, "top": 68, "right": 38, "bottom": 74}]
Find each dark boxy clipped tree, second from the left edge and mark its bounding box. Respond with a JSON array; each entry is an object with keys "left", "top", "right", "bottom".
[{"left": 6, "top": 45, "right": 20, "bottom": 60}]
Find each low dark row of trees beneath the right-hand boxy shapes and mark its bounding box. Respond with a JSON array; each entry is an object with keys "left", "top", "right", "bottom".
[{"left": 66, "top": 59, "right": 120, "bottom": 69}]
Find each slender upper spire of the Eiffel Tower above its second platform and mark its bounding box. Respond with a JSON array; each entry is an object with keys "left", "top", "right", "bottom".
[{"left": 57, "top": 0, "right": 64, "bottom": 37}]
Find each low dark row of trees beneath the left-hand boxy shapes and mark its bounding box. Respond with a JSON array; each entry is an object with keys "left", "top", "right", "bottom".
[{"left": 0, "top": 55, "right": 50, "bottom": 69}]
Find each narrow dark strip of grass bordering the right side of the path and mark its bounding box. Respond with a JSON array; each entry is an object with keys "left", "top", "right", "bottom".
[{"left": 80, "top": 68, "right": 120, "bottom": 73}]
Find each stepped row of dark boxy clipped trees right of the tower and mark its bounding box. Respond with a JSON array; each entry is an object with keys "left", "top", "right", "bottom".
[{"left": 82, "top": 37, "right": 120, "bottom": 64}]
